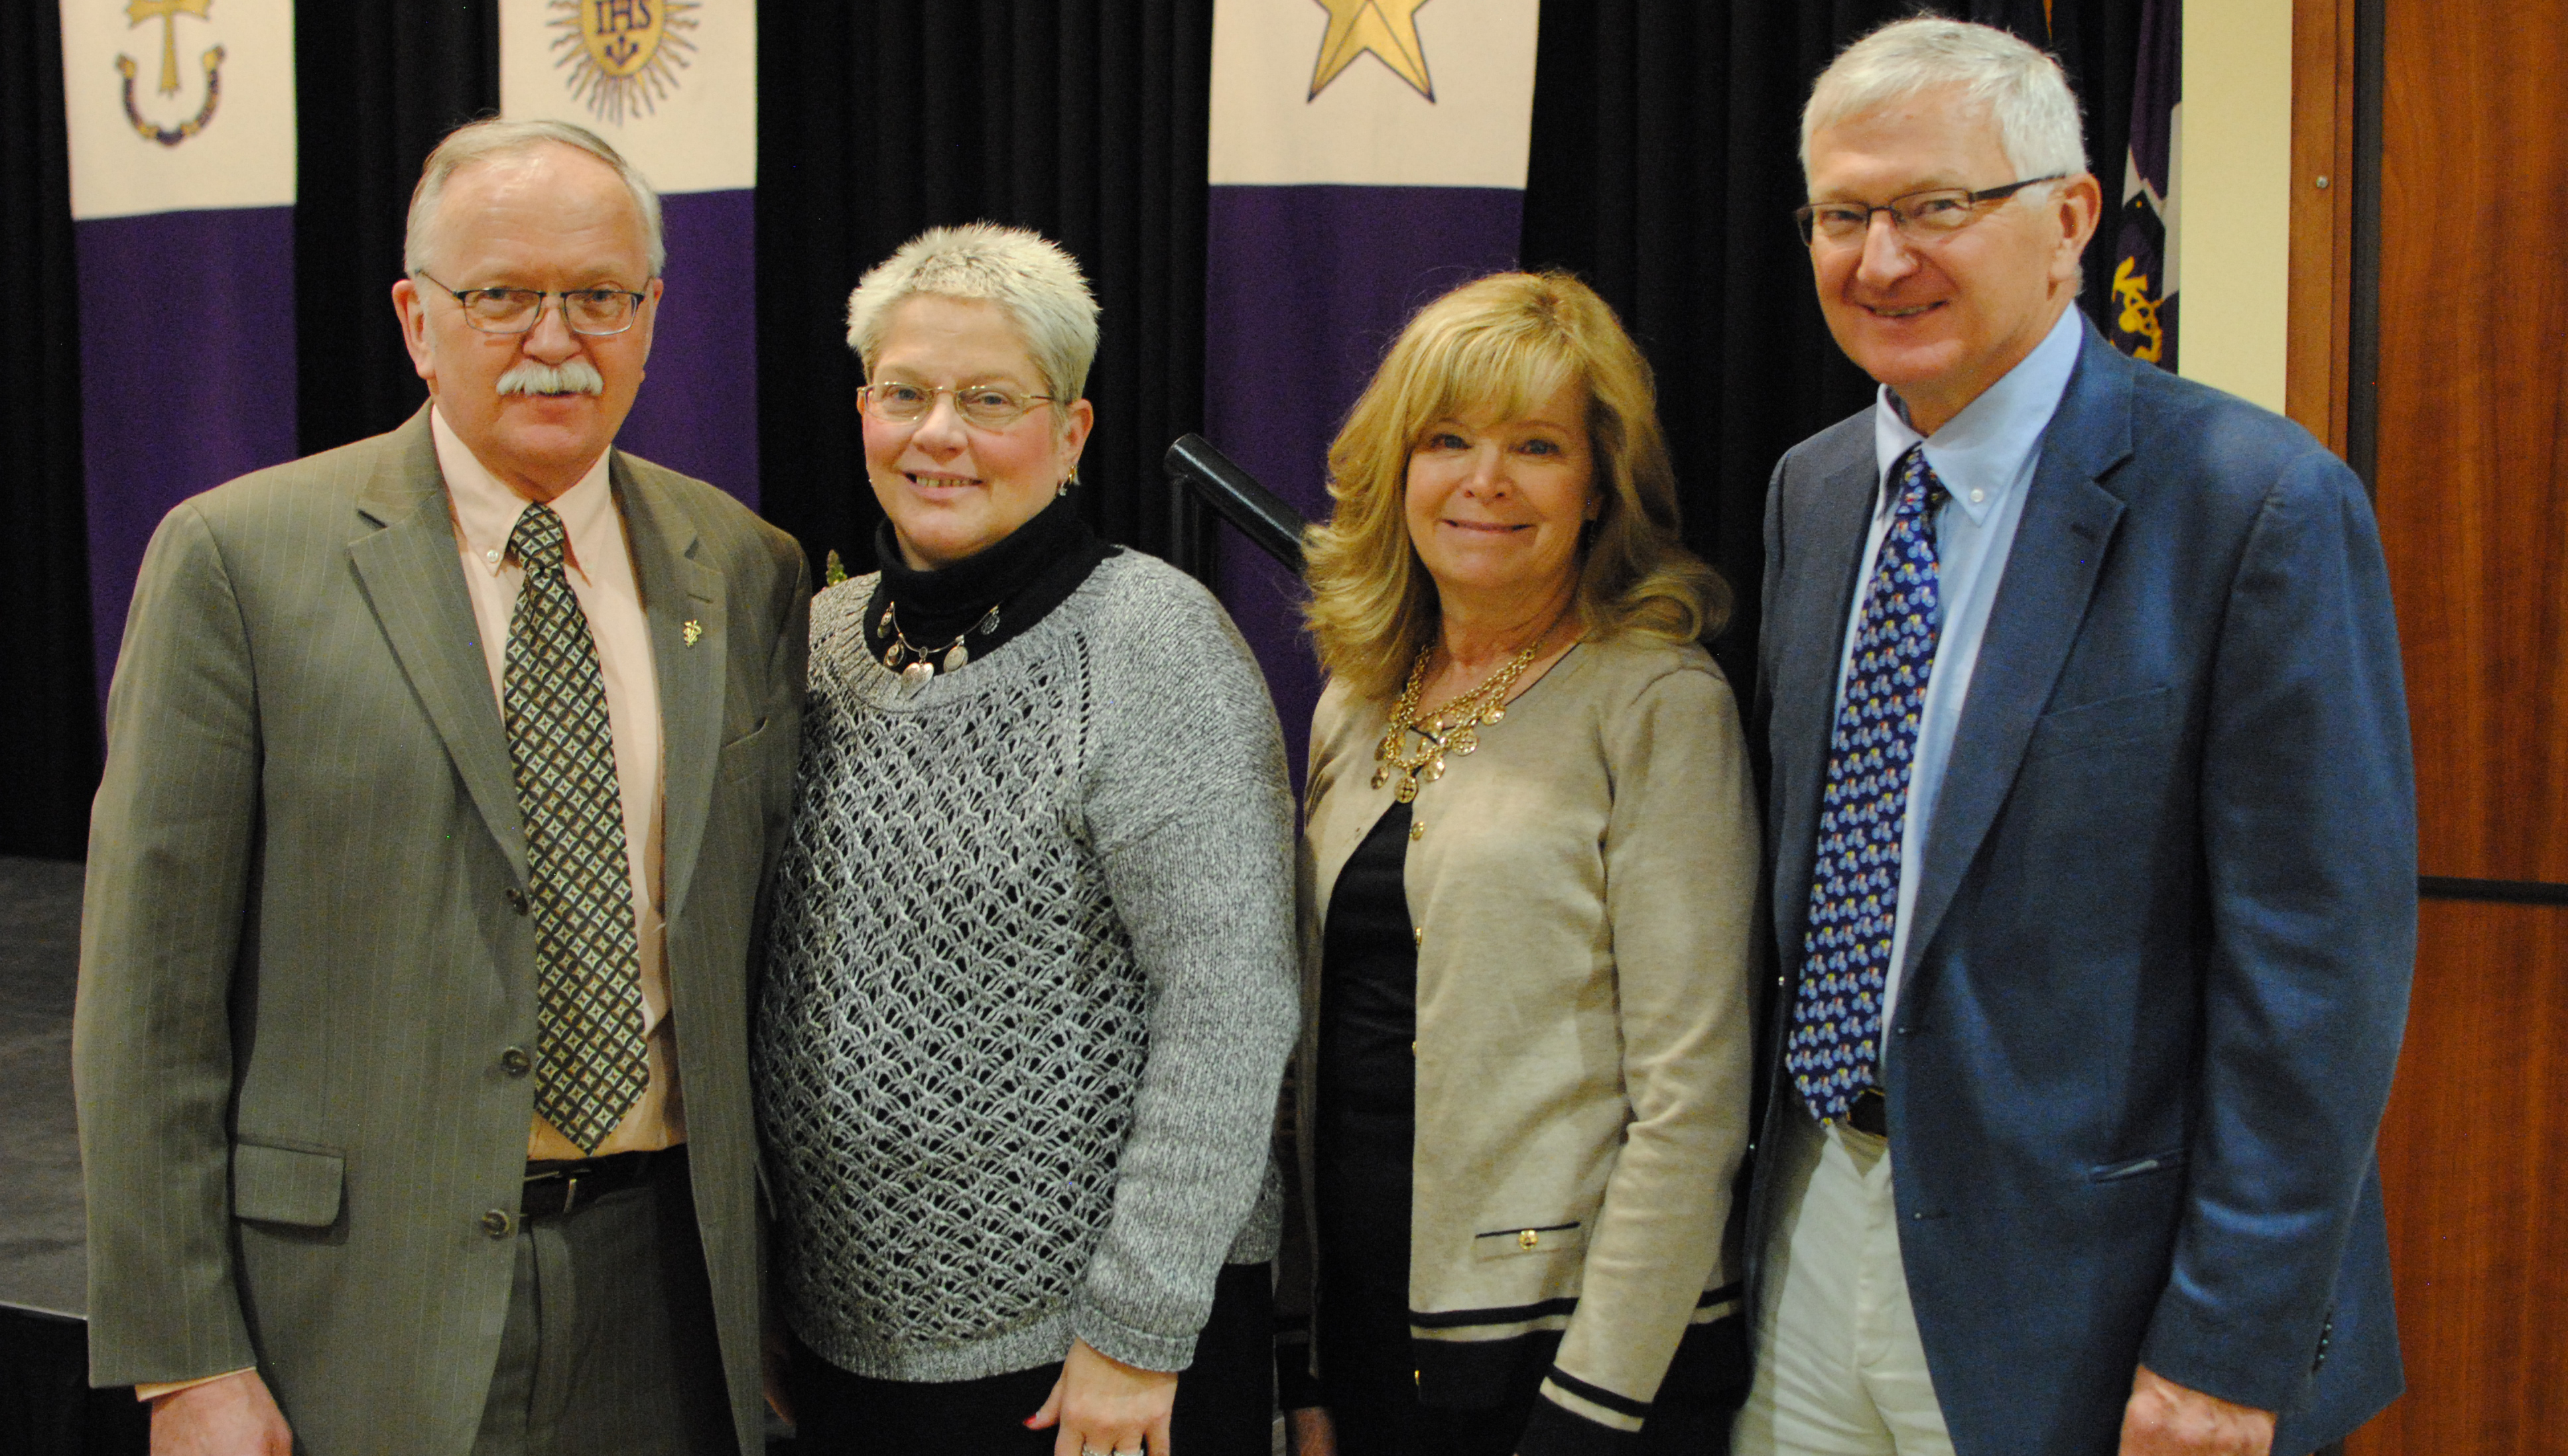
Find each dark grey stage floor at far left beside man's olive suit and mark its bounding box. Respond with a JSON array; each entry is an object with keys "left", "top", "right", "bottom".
[{"left": 0, "top": 858, "right": 90, "bottom": 1320}]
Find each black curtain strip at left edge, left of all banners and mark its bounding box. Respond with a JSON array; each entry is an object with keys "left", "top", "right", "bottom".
[{"left": 0, "top": 5, "right": 100, "bottom": 860}]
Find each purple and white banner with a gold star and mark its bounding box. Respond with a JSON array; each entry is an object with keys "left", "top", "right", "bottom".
[{"left": 1204, "top": 0, "right": 1541, "bottom": 778}]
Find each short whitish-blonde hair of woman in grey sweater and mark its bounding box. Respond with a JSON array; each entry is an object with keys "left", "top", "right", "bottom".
[{"left": 848, "top": 223, "right": 1096, "bottom": 403}]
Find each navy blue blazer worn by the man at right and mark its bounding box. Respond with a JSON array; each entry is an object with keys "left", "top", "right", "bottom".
[{"left": 1749, "top": 326, "right": 2417, "bottom": 1456}]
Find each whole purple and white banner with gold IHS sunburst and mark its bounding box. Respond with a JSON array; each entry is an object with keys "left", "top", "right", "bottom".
[{"left": 498, "top": 0, "right": 757, "bottom": 509}]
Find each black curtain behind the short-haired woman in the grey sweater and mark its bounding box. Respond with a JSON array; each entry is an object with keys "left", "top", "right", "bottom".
[{"left": 757, "top": 0, "right": 1212, "bottom": 573}]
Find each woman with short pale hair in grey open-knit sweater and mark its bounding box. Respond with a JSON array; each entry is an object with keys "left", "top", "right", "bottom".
[{"left": 752, "top": 223, "right": 1294, "bottom": 1456}]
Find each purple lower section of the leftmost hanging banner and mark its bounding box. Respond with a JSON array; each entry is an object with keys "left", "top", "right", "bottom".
[{"left": 74, "top": 208, "right": 295, "bottom": 701}]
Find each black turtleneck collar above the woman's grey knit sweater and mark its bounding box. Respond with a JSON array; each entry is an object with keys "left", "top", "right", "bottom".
[{"left": 866, "top": 495, "right": 1117, "bottom": 670}]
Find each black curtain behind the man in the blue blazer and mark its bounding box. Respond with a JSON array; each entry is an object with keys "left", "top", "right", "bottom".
[{"left": 1523, "top": 0, "right": 2139, "bottom": 688}]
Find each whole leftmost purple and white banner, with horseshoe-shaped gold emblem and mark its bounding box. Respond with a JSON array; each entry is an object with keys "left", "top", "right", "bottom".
[{"left": 62, "top": 0, "right": 295, "bottom": 696}]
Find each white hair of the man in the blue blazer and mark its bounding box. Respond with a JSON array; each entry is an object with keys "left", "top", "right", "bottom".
[{"left": 1800, "top": 15, "right": 2088, "bottom": 180}]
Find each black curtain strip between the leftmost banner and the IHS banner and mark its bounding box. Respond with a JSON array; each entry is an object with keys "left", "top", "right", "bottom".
[{"left": 295, "top": 0, "right": 498, "bottom": 455}]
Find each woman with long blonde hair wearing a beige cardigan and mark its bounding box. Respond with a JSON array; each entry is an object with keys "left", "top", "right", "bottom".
[{"left": 1279, "top": 274, "right": 1756, "bottom": 1456}]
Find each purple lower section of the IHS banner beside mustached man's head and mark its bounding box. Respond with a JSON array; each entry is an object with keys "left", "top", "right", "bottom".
[{"left": 616, "top": 190, "right": 757, "bottom": 511}]
